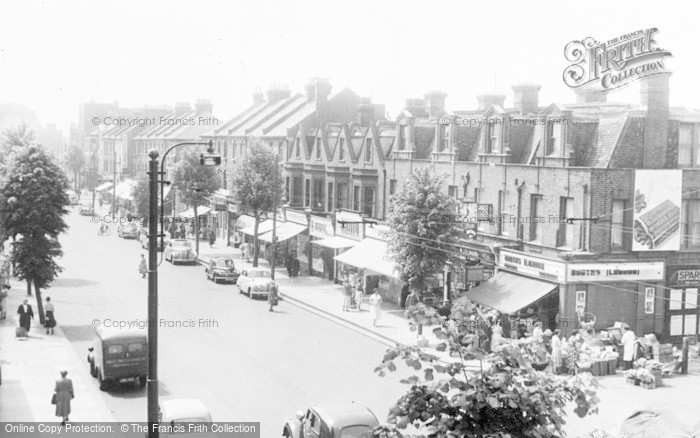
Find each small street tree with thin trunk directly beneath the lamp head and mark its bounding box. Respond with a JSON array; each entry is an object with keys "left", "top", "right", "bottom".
[{"left": 173, "top": 150, "right": 221, "bottom": 254}]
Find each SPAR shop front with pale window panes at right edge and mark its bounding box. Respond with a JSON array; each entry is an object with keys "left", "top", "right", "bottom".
[{"left": 665, "top": 265, "right": 700, "bottom": 344}]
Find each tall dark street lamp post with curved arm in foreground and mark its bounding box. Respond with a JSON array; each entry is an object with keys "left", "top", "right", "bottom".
[{"left": 147, "top": 141, "right": 220, "bottom": 438}]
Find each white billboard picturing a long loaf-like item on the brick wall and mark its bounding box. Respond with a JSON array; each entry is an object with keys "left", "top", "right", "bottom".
[{"left": 632, "top": 170, "right": 683, "bottom": 251}]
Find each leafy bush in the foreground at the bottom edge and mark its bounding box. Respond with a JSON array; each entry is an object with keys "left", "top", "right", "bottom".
[{"left": 374, "top": 298, "right": 599, "bottom": 438}]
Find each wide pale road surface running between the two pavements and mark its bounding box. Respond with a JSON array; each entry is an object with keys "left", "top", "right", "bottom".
[{"left": 45, "top": 210, "right": 405, "bottom": 436}]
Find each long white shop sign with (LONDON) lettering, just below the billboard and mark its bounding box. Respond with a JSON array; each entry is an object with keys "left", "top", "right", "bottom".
[{"left": 567, "top": 262, "right": 665, "bottom": 283}]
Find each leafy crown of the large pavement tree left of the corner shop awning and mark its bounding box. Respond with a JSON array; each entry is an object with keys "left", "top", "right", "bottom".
[{"left": 386, "top": 169, "right": 457, "bottom": 294}]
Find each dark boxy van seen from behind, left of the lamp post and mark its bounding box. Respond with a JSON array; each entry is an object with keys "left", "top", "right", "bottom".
[{"left": 88, "top": 328, "right": 148, "bottom": 391}]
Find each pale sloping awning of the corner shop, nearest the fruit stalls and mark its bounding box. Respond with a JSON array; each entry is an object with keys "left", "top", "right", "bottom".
[{"left": 466, "top": 272, "right": 558, "bottom": 314}]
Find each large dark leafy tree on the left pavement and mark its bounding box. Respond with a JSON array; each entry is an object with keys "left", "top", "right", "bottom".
[{"left": 0, "top": 144, "right": 70, "bottom": 321}]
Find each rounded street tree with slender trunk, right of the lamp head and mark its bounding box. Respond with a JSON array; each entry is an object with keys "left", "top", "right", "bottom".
[{"left": 231, "top": 142, "right": 283, "bottom": 266}]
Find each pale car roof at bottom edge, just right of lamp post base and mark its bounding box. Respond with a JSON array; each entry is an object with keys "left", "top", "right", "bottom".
[{"left": 158, "top": 399, "right": 220, "bottom": 438}]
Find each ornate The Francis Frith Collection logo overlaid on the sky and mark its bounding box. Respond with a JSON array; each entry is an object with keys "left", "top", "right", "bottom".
[{"left": 564, "top": 27, "right": 672, "bottom": 93}]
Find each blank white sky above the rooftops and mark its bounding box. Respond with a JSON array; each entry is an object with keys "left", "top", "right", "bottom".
[{"left": 0, "top": 0, "right": 700, "bottom": 132}]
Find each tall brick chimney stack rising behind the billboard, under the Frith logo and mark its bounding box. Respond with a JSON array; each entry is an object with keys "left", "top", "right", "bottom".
[{"left": 641, "top": 71, "right": 671, "bottom": 169}]
